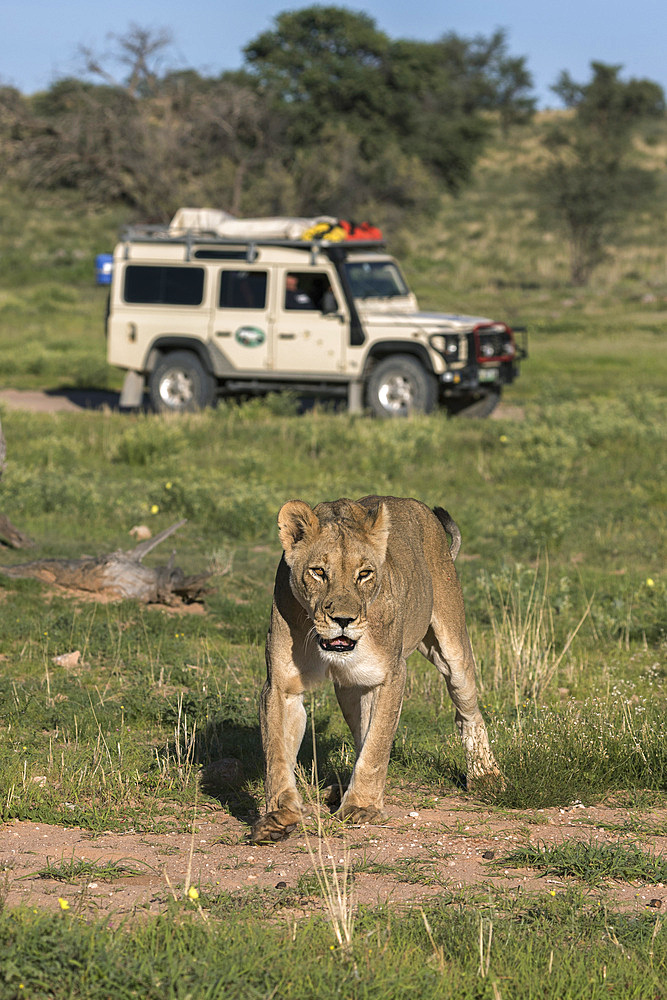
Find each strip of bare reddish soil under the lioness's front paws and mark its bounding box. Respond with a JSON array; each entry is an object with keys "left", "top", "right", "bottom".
[{"left": 0, "top": 795, "right": 667, "bottom": 919}]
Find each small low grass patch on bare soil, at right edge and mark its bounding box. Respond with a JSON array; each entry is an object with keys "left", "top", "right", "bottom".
[{"left": 494, "top": 841, "right": 667, "bottom": 886}]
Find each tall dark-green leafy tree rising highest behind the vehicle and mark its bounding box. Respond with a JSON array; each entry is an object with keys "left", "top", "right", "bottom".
[{"left": 244, "top": 6, "right": 532, "bottom": 188}]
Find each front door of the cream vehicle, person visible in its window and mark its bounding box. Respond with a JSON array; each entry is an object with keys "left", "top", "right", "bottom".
[{"left": 273, "top": 268, "right": 350, "bottom": 376}]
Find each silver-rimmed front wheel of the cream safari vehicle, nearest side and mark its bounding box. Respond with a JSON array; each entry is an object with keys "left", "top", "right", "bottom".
[{"left": 366, "top": 354, "right": 438, "bottom": 417}]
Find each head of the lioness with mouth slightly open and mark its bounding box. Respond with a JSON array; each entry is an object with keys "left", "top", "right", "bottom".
[{"left": 278, "top": 500, "right": 390, "bottom": 661}]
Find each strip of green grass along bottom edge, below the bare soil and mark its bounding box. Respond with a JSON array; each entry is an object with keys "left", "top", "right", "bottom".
[{"left": 0, "top": 893, "right": 667, "bottom": 1000}]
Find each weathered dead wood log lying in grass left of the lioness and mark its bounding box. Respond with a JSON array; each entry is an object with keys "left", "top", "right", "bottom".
[{"left": 0, "top": 519, "right": 211, "bottom": 604}]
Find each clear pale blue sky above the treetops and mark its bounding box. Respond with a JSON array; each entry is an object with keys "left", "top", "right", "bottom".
[{"left": 0, "top": 0, "right": 667, "bottom": 107}]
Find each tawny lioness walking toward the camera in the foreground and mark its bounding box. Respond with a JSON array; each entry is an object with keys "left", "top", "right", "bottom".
[{"left": 252, "top": 496, "right": 500, "bottom": 842}]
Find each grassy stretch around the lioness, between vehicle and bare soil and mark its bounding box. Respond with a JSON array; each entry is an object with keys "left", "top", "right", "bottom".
[{"left": 0, "top": 398, "right": 667, "bottom": 831}]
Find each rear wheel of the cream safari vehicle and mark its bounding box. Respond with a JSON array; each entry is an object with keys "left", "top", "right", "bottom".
[{"left": 148, "top": 351, "right": 215, "bottom": 413}]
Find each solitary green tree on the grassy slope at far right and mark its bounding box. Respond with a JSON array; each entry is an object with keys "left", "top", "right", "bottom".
[{"left": 538, "top": 62, "right": 665, "bottom": 285}]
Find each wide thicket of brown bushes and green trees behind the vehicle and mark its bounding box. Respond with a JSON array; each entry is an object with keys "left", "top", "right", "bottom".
[{"left": 5, "top": 6, "right": 532, "bottom": 222}]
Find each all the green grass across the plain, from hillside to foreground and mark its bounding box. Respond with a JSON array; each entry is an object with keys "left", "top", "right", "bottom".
[{"left": 0, "top": 115, "right": 667, "bottom": 1000}]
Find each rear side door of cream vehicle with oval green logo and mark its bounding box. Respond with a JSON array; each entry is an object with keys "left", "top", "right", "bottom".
[{"left": 211, "top": 263, "right": 271, "bottom": 372}]
